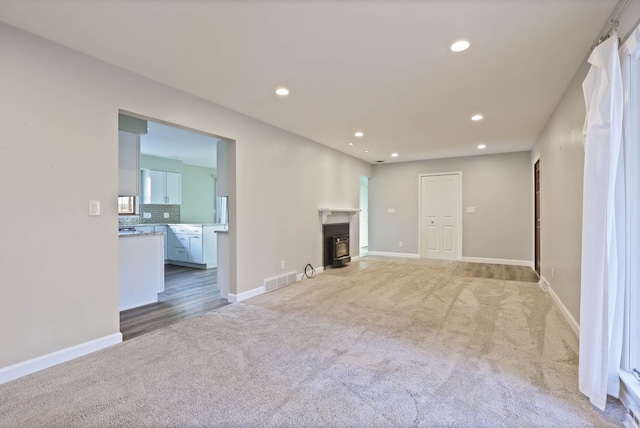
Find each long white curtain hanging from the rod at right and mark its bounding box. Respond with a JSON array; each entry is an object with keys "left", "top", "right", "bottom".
[{"left": 579, "top": 33, "right": 626, "bottom": 410}]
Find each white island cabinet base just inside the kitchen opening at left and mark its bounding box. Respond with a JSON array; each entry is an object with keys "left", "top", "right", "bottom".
[{"left": 119, "top": 231, "right": 164, "bottom": 311}]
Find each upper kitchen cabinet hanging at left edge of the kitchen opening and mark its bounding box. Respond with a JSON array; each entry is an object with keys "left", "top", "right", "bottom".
[{"left": 118, "top": 131, "right": 140, "bottom": 196}]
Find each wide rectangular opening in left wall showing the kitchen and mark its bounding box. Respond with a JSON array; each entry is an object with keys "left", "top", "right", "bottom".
[{"left": 118, "top": 113, "right": 229, "bottom": 340}]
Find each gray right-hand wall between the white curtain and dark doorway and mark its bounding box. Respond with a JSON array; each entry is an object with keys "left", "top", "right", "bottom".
[{"left": 532, "top": 63, "right": 589, "bottom": 322}]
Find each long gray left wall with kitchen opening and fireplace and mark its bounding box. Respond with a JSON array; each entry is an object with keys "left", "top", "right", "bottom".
[{"left": 0, "top": 23, "right": 371, "bottom": 368}]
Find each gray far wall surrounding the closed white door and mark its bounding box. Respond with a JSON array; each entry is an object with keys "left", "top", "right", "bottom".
[{"left": 369, "top": 152, "right": 533, "bottom": 261}]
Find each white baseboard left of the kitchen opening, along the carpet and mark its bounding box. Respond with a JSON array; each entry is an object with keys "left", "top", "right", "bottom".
[{"left": 0, "top": 333, "right": 122, "bottom": 385}]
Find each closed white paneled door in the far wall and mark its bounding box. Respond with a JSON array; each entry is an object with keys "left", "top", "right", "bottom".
[{"left": 420, "top": 173, "right": 462, "bottom": 260}]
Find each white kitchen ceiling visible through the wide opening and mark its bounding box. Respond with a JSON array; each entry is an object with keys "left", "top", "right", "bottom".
[{"left": 140, "top": 121, "right": 219, "bottom": 168}]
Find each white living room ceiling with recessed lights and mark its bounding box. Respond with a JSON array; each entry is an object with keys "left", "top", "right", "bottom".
[{"left": 0, "top": 0, "right": 617, "bottom": 163}]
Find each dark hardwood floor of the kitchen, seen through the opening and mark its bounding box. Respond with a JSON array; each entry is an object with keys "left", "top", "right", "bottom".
[{"left": 120, "top": 265, "right": 228, "bottom": 340}]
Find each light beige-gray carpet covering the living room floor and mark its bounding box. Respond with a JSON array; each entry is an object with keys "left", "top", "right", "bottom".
[{"left": 0, "top": 259, "right": 625, "bottom": 427}]
